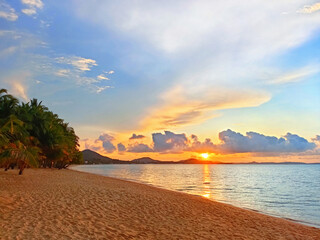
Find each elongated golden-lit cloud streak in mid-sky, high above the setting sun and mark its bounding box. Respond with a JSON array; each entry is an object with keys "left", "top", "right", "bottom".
[{"left": 141, "top": 86, "right": 270, "bottom": 130}]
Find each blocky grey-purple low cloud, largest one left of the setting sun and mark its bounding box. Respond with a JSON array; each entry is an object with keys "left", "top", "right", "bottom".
[{"left": 152, "top": 131, "right": 188, "bottom": 153}]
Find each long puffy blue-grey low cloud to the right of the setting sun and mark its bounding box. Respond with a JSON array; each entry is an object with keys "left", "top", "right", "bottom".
[{"left": 216, "top": 129, "right": 316, "bottom": 154}]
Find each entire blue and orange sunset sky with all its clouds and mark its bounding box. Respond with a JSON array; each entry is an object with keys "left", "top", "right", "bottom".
[{"left": 0, "top": 0, "right": 320, "bottom": 163}]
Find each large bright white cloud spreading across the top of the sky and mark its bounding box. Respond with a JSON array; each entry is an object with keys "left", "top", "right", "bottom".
[{"left": 76, "top": 0, "right": 319, "bottom": 57}]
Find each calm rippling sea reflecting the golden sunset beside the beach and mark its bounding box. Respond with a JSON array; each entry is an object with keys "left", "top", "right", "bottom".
[{"left": 75, "top": 164, "right": 320, "bottom": 227}]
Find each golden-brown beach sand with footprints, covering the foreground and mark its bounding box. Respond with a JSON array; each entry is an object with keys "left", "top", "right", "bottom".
[{"left": 0, "top": 169, "right": 320, "bottom": 240}]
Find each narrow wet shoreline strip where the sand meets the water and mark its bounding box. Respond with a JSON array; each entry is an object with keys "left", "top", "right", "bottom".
[{"left": 68, "top": 164, "right": 320, "bottom": 229}]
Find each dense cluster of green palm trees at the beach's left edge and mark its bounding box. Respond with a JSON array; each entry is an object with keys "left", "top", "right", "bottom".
[{"left": 0, "top": 89, "right": 83, "bottom": 173}]
